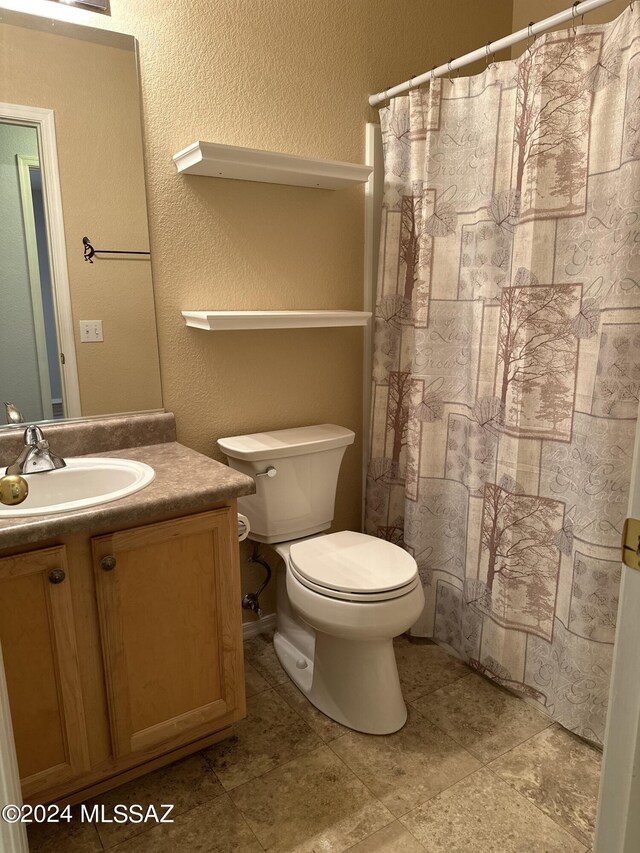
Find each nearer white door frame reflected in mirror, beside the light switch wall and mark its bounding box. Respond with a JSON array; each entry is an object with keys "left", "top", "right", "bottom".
[{"left": 0, "top": 103, "right": 82, "bottom": 418}]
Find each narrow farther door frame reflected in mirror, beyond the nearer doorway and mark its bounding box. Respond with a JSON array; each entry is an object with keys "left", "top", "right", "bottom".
[{"left": 16, "top": 154, "right": 53, "bottom": 420}]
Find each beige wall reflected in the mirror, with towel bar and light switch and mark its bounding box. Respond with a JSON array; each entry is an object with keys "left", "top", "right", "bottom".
[{"left": 0, "top": 25, "right": 162, "bottom": 415}]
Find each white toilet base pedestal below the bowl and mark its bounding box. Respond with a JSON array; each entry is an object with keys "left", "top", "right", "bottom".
[{"left": 273, "top": 629, "right": 407, "bottom": 735}]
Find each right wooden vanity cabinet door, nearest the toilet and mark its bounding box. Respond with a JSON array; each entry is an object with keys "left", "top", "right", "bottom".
[{"left": 92, "top": 508, "right": 245, "bottom": 757}]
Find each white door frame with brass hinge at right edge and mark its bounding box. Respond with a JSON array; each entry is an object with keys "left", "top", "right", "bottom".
[{"left": 593, "top": 423, "right": 640, "bottom": 853}]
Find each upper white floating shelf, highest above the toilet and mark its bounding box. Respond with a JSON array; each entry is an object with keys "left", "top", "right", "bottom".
[{"left": 173, "top": 142, "right": 373, "bottom": 190}]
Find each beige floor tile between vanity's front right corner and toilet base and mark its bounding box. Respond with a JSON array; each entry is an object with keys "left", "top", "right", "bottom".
[{"left": 204, "top": 689, "right": 321, "bottom": 791}]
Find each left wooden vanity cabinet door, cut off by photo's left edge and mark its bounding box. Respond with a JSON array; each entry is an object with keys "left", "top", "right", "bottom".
[{"left": 0, "top": 546, "right": 89, "bottom": 799}]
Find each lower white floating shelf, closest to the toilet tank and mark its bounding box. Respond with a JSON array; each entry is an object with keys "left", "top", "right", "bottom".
[{"left": 182, "top": 311, "right": 371, "bottom": 332}]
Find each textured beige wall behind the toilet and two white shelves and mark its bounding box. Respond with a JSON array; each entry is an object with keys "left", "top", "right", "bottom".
[{"left": 3, "top": 0, "right": 512, "bottom": 610}]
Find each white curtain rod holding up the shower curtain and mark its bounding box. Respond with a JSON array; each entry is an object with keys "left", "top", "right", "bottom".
[{"left": 369, "top": 0, "right": 633, "bottom": 107}]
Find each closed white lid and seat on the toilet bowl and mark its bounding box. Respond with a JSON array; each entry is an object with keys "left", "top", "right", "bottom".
[{"left": 289, "top": 530, "right": 418, "bottom": 593}]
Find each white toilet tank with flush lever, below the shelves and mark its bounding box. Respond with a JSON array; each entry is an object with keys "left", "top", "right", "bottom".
[{"left": 218, "top": 424, "right": 355, "bottom": 542}]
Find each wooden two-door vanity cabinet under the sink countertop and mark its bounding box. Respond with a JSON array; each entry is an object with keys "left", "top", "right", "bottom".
[{"left": 0, "top": 500, "right": 245, "bottom": 802}]
